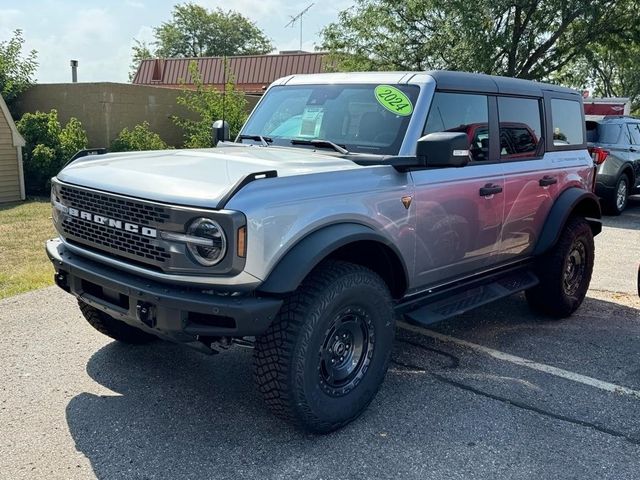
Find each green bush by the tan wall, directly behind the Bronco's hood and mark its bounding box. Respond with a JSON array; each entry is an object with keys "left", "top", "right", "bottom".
[{"left": 174, "top": 62, "right": 247, "bottom": 148}]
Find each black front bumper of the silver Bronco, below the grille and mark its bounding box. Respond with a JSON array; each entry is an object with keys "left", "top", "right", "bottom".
[{"left": 46, "top": 239, "right": 282, "bottom": 343}]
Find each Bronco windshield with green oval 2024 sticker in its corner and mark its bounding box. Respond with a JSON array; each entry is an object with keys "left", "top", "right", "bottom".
[{"left": 242, "top": 85, "right": 419, "bottom": 155}]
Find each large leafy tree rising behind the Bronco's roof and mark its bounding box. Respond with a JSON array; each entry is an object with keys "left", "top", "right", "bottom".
[{"left": 321, "top": 0, "right": 640, "bottom": 80}]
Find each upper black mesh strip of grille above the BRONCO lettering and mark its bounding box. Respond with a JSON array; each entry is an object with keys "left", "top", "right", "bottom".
[{"left": 58, "top": 185, "right": 169, "bottom": 226}]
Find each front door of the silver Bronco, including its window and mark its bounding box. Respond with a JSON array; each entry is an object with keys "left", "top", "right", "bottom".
[{"left": 411, "top": 92, "right": 504, "bottom": 286}]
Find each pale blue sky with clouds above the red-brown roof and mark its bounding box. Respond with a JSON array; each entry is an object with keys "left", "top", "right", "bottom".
[{"left": 0, "top": 0, "right": 353, "bottom": 83}]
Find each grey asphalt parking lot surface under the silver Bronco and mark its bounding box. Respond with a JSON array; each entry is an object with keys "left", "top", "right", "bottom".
[{"left": 0, "top": 199, "right": 640, "bottom": 479}]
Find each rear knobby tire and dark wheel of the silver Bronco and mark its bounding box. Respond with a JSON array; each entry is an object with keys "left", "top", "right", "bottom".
[{"left": 526, "top": 217, "right": 594, "bottom": 318}]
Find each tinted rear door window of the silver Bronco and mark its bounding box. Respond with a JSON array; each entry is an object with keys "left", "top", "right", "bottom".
[{"left": 498, "top": 97, "right": 542, "bottom": 159}]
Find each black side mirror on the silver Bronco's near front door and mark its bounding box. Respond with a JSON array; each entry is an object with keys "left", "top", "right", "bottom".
[{"left": 416, "top": 132, "right": 469, "bottom": 167}]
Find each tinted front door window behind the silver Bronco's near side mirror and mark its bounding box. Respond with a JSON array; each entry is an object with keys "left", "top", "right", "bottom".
[{"left": 424, "top": 92, "right": 489, "bottom": 162}]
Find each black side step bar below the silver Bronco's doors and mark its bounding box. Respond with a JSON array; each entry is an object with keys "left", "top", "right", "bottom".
[{"left": 397, "top": 270, "right": 539, "bottom": 325}]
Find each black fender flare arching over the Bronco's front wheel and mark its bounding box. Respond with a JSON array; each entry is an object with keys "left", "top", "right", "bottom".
[{"left": 257, "top": 223, "right": 409, "bottom": 294}]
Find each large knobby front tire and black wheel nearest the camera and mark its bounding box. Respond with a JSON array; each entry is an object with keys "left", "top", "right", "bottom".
[{"left": 254, "top": 261, "right": 395, "bottom": 433}]
